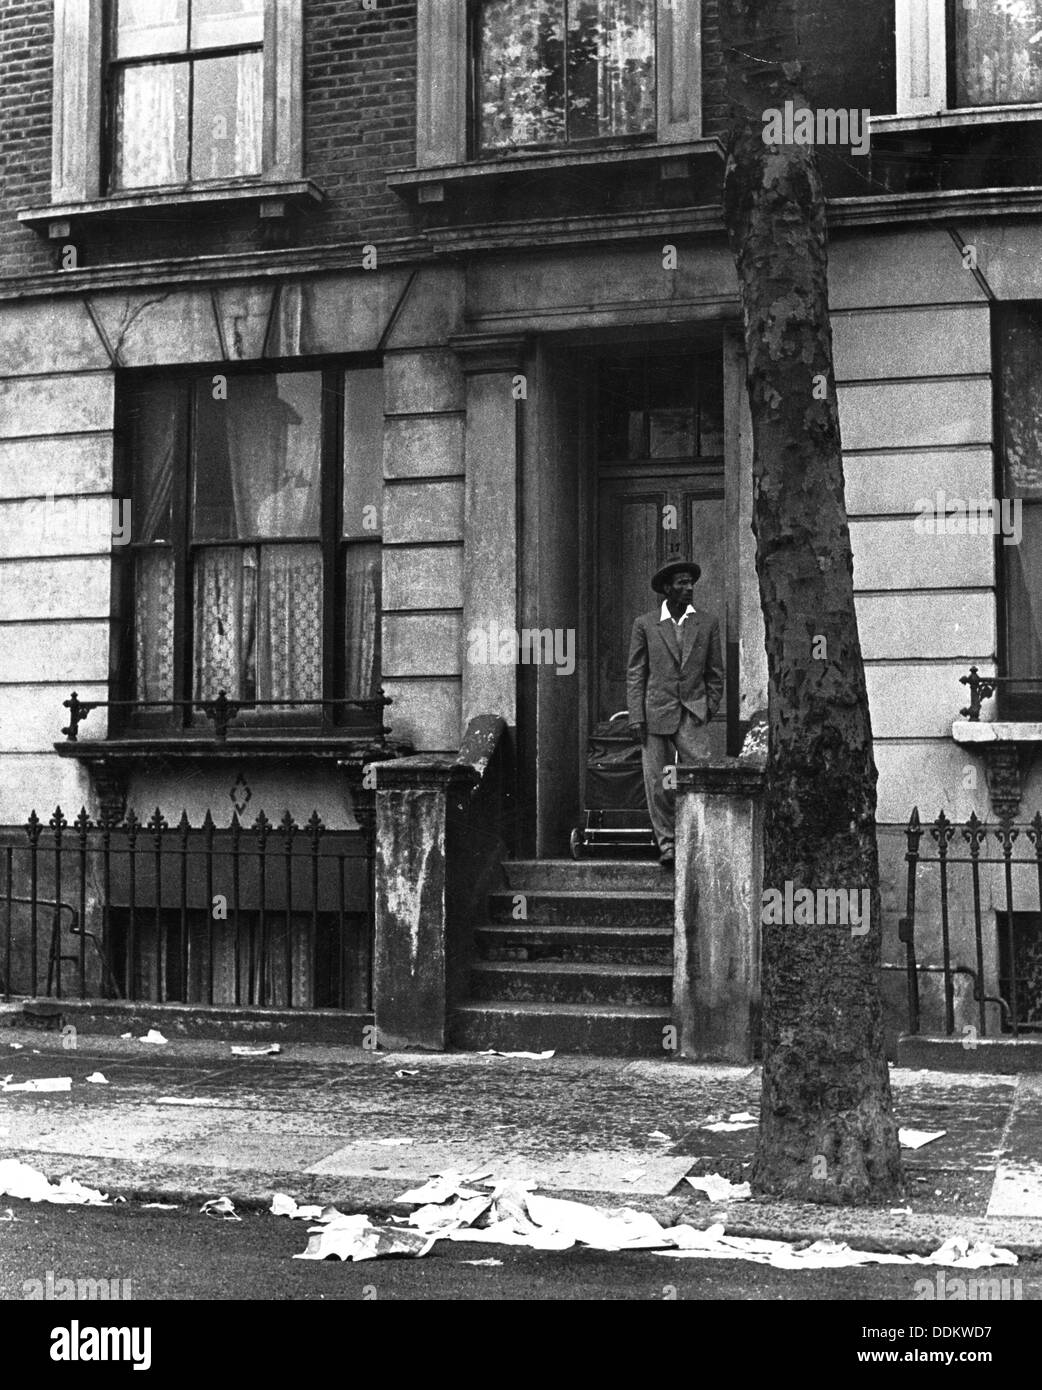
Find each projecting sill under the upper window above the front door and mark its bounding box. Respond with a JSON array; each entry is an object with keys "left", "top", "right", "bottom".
[{"left": 388, "top": 136, "right": 724, "bottom": 203}]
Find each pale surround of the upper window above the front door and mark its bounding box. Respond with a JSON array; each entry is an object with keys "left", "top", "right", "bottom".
[{"left": 417, "top": 0, "right": 702, "bottom": 170}]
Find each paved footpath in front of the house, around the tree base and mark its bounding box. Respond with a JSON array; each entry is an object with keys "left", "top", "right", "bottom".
[{"left": 0, "top": 1027, "right": 1042, "bottom": 1258}]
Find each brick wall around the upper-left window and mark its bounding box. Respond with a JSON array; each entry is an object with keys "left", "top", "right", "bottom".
[{"left": 0, "top": 0, "right": 415, "bottom": 275}]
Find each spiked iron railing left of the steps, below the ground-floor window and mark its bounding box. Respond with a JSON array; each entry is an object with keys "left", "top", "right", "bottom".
[{"left": 0, "top": 808, "right": 372, "bottom": 1011}]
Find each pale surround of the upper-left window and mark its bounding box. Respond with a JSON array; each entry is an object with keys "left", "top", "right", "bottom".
[{"left": 51, "top": 0, "right": 304, "bottom": 208}]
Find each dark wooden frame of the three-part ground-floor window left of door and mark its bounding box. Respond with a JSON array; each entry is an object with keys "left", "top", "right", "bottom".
[{"left": 108, "top": 354, "right": 383, "bottom": 738}]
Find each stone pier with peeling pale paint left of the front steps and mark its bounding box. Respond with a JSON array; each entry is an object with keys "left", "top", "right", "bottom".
[{"left": 368, "top": 756, "right": 475, "bottom": 1051}]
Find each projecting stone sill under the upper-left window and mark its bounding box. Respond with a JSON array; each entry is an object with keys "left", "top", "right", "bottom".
[{"left": 18, "top": 179, "right": 325, "bottom": 239}]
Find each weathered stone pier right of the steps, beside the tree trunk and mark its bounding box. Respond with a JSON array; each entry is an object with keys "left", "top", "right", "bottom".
[{"left": 672, "top": 760, "right": 763, "bottom": 1063}]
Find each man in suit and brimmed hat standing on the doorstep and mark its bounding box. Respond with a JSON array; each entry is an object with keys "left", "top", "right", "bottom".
[{"left": 627, "top": 560, "right": 724, "bottom": 869}]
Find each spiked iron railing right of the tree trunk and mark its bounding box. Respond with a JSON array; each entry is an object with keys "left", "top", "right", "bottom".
[{"left": 899, "top": 808, "right": 1042, "bottom": 1037}]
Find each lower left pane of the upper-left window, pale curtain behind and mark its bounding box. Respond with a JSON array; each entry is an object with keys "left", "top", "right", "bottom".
[{"left": 115, "top": 63, "right": 188, "bottom": 188}]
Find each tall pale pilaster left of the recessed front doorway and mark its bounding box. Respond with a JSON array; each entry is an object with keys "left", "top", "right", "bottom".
[{"left": 450, "top": 334, "right": 527, "bottom": 733}]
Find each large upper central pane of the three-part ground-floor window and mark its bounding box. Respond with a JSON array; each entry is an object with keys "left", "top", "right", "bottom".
[{"left": 192, "top": 371, "right": 322, "bottom": 541}]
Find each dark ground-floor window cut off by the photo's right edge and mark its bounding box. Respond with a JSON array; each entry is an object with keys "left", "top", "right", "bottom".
[{"left": 999, "top": 306, "right": 1042, "bottom": 694}]
